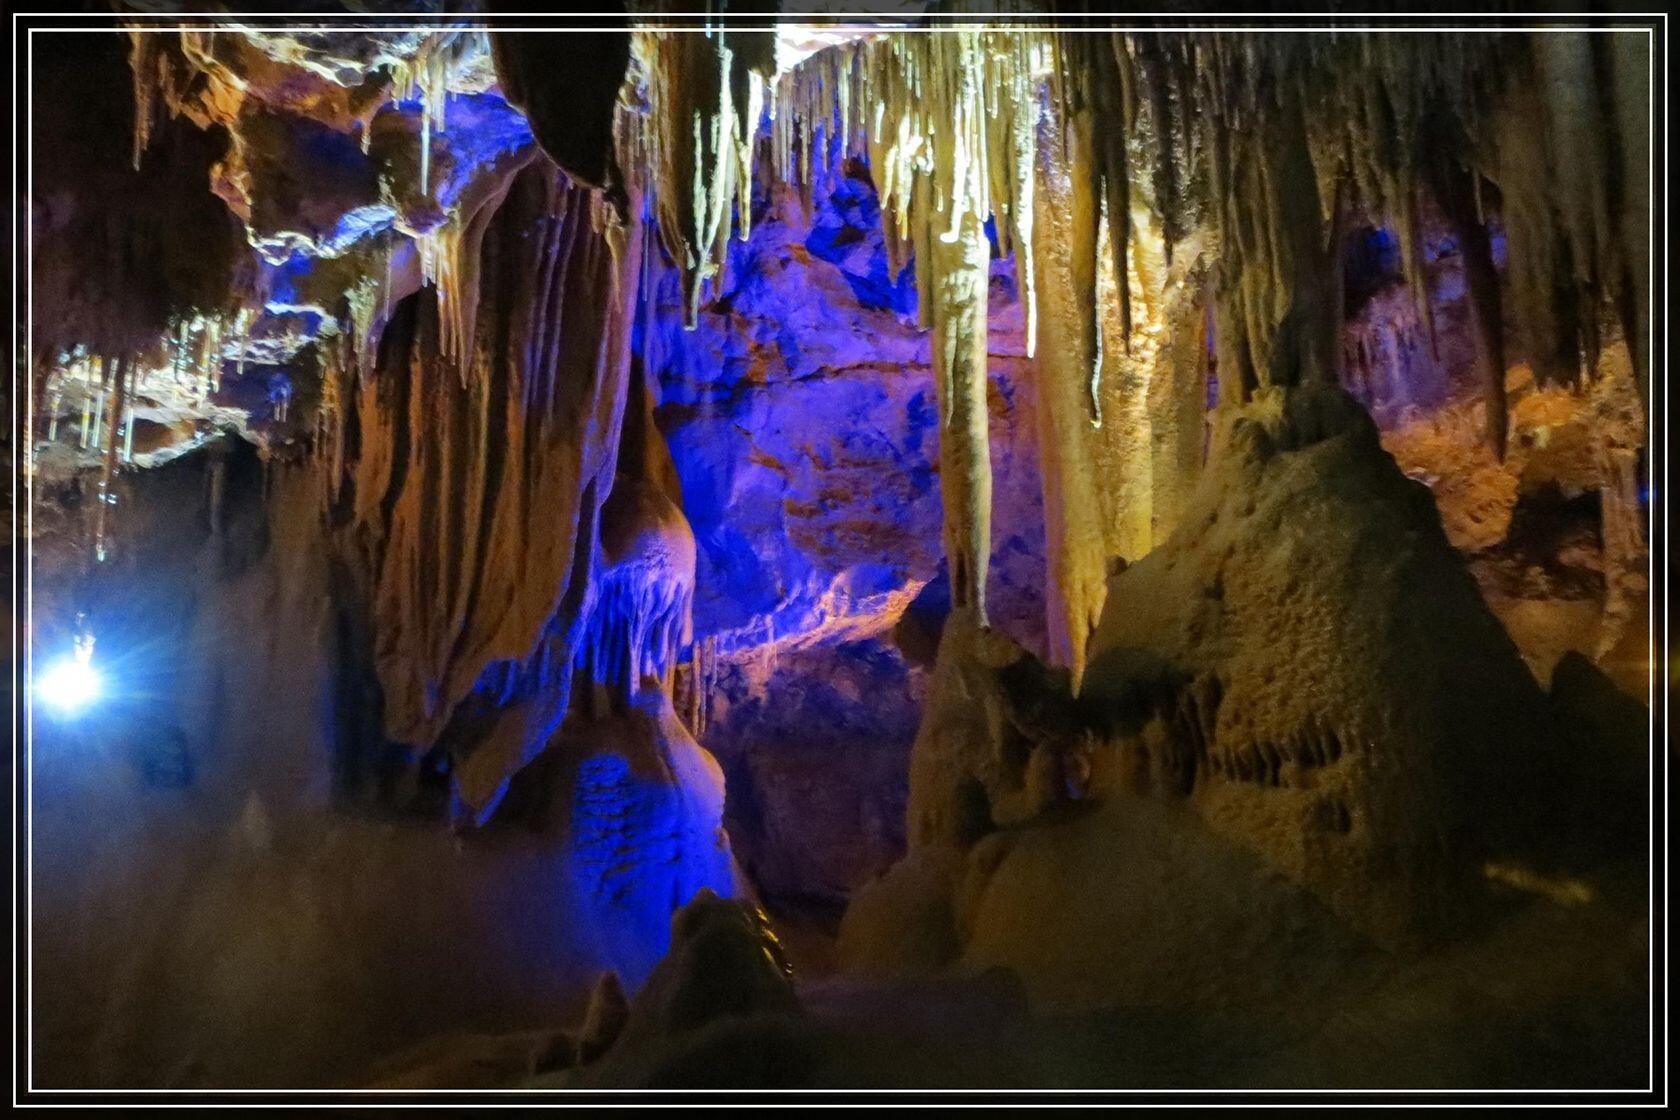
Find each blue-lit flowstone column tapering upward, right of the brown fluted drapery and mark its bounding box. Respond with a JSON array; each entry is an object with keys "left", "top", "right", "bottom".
[{"left": 549, "top": 367, "right": 743, "bottom": 984}]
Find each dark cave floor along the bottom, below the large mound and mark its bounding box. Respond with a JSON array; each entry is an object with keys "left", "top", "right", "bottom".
[{"left": 520, "top": 846, "right": 1648, "bottom": 1090}]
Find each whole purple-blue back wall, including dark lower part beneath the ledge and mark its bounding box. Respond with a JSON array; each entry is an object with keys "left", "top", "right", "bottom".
[{"left": 640, "top": 165, "right": 1043, "bottom": 902}]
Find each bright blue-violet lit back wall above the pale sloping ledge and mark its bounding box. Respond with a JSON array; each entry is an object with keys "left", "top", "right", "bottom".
[{"left": 642, "top": 165, "right": 1042, "bottom": 653}]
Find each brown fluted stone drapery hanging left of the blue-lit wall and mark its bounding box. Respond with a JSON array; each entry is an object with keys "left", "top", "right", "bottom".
[{"left": 325, "top": 161, "right": 638, "bottom": 819}]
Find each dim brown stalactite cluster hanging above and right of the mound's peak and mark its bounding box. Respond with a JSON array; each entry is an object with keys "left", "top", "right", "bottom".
[{"left": 1169, "top": 32, "right": 1650, "bottom": 429}]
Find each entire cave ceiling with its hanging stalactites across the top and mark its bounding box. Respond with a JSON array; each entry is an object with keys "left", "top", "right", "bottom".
[{"left": 30, "top": 5, "right": 1648, "bottom": 816}]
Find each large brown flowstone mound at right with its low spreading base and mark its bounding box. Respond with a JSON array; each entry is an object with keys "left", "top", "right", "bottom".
[{"left": 840, "top": 390, "right": 1643, "bottom": 1034}]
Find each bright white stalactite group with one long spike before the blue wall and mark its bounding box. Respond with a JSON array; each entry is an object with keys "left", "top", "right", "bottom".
[{"left": 773, "top": 27, "right": 1048, "bottom": 618}]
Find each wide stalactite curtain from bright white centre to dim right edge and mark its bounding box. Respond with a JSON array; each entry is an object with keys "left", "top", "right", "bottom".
[{"left": 771, "top": 27, "right": 1648, "bottom": 673}]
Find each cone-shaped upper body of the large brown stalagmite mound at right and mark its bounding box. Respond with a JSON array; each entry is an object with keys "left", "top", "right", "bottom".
[{"left": 1090, "top": 391, "right": 1554, "bottom": 937}]
